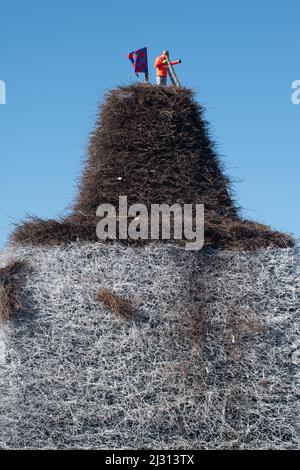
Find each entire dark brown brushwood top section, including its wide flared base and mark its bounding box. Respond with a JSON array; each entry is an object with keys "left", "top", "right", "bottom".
[{"left": 12, "top": 84, "right": 294, "bottom": 249}]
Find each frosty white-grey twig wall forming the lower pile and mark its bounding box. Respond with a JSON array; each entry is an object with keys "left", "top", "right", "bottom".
[{"left": 0, "top": 243, "right": 300, "bottom": 449}]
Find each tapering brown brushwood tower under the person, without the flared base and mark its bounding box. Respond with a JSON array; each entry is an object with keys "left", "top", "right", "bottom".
[{"left": 75, "top": 85, "right": 236, "bottom": 215}]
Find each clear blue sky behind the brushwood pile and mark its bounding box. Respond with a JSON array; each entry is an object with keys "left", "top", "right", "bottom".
[{"left": 0, "top": 0, "right": 300, "bottom": 246}]
